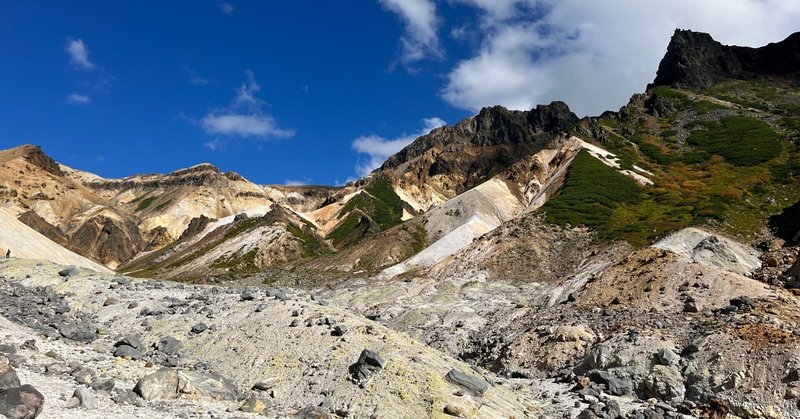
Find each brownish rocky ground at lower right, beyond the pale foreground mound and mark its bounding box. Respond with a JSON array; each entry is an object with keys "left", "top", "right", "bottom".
[{"left": 322, "top": 229, "right": 800, "bottom": 418}]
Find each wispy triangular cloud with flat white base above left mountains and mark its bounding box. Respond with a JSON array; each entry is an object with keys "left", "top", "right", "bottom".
[{"left": 200, "top": 70, "right": 295, "bottom": 141}]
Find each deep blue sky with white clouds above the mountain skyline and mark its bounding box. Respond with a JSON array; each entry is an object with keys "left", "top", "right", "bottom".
[{"left": 0, "top": 0, "right": 800, "bottom": 184}]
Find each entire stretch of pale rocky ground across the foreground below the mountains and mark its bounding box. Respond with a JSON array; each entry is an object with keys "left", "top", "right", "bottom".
[{"left": 0, "top": 228, "right": 800, "bottom": 419}]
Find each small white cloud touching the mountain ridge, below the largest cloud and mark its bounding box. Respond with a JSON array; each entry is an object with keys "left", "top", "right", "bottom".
[{"left": 353, "top": 118, "right": 447, "bottom": 177}]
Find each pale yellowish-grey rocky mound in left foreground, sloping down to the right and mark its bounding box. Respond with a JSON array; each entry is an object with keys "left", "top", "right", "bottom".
[{"left": 0, "top": 259, "right": 592, "bottom": 418}]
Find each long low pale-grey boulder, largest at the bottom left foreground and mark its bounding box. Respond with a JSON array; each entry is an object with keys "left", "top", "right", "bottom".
[{"left": 133, "top": 368, "right": 239, "bottom": 400}]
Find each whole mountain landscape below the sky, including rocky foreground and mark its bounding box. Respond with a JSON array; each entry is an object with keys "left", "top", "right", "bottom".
[{"left": 0, "top": 30, "right": 800, "bottom": 419}]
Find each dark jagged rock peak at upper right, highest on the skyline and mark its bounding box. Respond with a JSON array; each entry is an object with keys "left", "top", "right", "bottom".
[{"left": 648, "top": 29, "right": 800, "bottom": 89}]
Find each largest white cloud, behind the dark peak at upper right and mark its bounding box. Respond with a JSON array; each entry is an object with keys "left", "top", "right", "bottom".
[{"left": 441, "top": 0, "right": 800, "bottom": 115}]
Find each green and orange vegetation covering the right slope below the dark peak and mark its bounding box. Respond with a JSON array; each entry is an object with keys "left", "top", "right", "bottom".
[{"left": 543, "top": 80, "right": 800, "bottom": 245}]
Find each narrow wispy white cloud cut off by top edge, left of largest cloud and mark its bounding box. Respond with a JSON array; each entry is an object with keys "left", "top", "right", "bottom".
[{"left": 378, "top": 0, "right": 444, "bottom": 65}]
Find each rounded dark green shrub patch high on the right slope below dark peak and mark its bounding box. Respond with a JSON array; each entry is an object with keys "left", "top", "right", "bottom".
[{"left": 689, "top": 116, "right": 783, "bottom": 166}]
